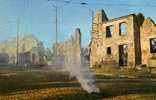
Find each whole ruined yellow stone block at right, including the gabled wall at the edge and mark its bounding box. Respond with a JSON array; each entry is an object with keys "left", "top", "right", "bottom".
[{"left": 90, "top": 10, "right": 156, "bottom": 67}]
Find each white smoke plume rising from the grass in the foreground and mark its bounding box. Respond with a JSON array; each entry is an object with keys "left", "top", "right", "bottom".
[{"left": 65, "top": 54, "right": 100, "bottom": 93}]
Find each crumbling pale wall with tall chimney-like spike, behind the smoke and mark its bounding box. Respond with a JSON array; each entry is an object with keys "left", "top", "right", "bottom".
[{"left": 54, "top": 28, "right": 81, "bottom": 66}]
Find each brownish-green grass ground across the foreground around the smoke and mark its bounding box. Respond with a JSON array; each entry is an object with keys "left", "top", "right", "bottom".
[{"left": 0, "top": 68, "right": 156, "bottom": 100}]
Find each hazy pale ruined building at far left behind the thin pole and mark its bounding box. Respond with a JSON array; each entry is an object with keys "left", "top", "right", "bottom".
[{"left": 0, "top": 35, "right": 44, "bottom": 65}]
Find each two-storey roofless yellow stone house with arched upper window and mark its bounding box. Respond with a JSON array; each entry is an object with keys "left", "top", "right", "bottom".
[{"left": 90, "top": 10, "right": 141, "bottom": 67}]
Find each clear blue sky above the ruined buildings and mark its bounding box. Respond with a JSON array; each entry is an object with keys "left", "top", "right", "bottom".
[{"left": 0, "top": 0, "right": 156, "bottom": 48}]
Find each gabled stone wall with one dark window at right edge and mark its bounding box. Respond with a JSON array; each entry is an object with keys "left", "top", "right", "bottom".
[{"left": 140, "top": 18, "right": 156, "bottom": 67}]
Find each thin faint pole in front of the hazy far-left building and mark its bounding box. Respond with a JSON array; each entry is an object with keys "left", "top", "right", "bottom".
[{"left": 16, "top": 19, "right": 20, "bottom": 66}]
